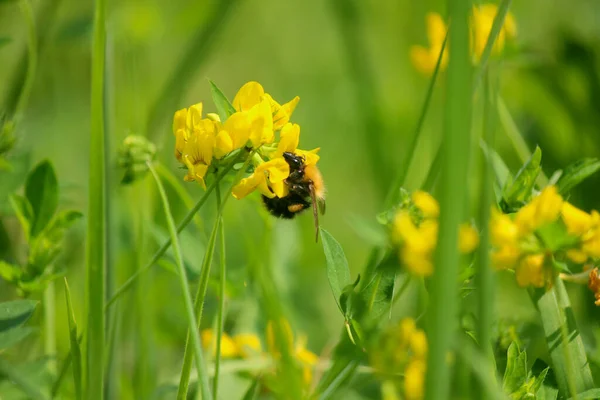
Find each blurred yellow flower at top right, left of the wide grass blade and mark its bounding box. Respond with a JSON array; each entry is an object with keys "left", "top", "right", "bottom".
[{"left": 410, "top": 13, "right": 448, "bottom": 75}]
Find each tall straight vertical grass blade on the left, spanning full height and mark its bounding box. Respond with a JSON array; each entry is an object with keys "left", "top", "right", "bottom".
[{"left": 84, "top": 0, "right": 106, "bottom": 400}]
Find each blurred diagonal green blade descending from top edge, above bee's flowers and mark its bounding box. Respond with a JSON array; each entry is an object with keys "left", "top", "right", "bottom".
[{"left": 144, "top": 0, "right": 238, "bottom": 141}]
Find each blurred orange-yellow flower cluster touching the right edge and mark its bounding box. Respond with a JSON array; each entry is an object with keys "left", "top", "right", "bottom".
[{"left": 490, "top": 186, "right": 600, "bottom": 287}]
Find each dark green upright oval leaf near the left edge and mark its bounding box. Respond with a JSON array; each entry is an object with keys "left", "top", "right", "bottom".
[{"left": 25, "top": 160, "right": 58, "bottom": 237}]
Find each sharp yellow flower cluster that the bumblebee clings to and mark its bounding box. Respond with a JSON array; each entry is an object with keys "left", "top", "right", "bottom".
[{"left": 173, "top": 82, "right": 319, "bottom": 199}]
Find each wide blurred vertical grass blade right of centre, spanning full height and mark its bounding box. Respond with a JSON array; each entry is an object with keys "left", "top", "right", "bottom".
[{"left": 425, "top": 0, "right": 472, "bottom": 400}]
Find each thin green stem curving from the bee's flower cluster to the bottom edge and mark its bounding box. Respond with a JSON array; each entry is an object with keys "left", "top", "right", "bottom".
[{"left": 177, "top": 152, "right": 254, "bottom": 400}]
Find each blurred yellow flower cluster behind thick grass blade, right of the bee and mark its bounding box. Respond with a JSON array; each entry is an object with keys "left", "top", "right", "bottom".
[{"left": 392, "top": 191, "right": 479, "bottom": 276}]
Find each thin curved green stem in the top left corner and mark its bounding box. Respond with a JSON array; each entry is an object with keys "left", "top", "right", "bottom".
[{"left": 14, "top": 0, "right": 38, "bottom": 124}]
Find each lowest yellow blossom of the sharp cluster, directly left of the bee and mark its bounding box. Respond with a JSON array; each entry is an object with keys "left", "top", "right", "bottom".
[{"left": 232, "top": 157, "right": 290, "bottom": 200}]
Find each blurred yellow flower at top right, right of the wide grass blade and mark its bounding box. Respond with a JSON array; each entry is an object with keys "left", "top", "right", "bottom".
[{"left": 471, "top": 4, "right": 517, "bottom": 60}]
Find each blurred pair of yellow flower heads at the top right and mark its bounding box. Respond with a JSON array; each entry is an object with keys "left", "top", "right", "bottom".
[{"left": 410, "top": 4, "right": 517, "bottom": 75}]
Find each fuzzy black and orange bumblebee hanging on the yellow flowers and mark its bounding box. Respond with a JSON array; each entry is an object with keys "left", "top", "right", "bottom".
[{"left": 262, "top": 152, "right": 325, "bottom": 240}]
